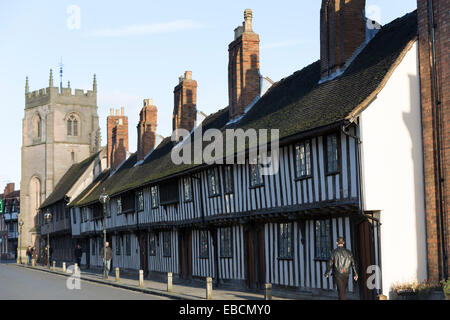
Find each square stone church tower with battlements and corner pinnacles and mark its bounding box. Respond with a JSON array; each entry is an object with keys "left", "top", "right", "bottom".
[{"left": 19, "top": 70, "right": 101, "bottom": 256}]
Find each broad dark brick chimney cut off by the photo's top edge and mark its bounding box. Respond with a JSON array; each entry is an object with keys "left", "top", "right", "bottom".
[{"left": 320, "top": 0, "right": 366, "bottom": 79}]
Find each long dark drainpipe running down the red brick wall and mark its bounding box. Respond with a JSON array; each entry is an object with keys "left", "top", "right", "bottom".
[{"left": 428, "top": 0, "right": 448, "bottom": 279}]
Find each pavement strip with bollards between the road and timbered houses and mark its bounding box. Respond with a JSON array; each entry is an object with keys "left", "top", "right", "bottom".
[{"left": 8, "top": 264, "right": 312, "bottom": 300}]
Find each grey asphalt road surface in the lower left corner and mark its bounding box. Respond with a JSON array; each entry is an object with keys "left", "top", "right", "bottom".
[{"left": 0, "top": 263, "right": 167, "bottom": 300}]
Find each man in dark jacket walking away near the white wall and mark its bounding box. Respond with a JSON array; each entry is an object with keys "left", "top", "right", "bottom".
[{"left": 325, "top": 237, "right": 358, "bottom": 300}]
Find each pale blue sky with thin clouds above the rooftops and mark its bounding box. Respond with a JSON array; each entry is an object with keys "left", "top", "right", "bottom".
[{"left": 0, "top": 0, "right": 417, "bottom": 193}]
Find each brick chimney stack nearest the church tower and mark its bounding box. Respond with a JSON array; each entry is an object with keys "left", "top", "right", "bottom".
[{"left": 106, "top": 107, "right": 128, "bottom": 168}]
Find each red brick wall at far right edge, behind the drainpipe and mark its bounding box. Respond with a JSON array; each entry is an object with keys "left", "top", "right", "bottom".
[{"left": 417, "top": 0, "right": 450, "bottom": 281}]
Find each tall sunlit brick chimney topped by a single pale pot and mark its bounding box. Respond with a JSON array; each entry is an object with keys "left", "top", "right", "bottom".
[{"left": 228, "top": 9, "right": 261, "bottom": 119}]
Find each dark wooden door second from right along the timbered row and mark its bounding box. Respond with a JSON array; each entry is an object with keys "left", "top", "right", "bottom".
[{"left": 244, "top": 226, "right": 266, "bottom": 289}]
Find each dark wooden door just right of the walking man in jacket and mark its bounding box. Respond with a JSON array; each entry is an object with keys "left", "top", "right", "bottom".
[{"left": 358, "top": 220, "right": 376, "bottom": 299}]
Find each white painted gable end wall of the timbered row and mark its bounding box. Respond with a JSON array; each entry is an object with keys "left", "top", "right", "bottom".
[{"left": 360, "top": 42, "right": 427, "bottom": 296}]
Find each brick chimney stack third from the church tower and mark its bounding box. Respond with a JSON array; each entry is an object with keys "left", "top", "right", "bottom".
[{"left": 172, "top": 71, "right": 197, "bottom": 131}]
